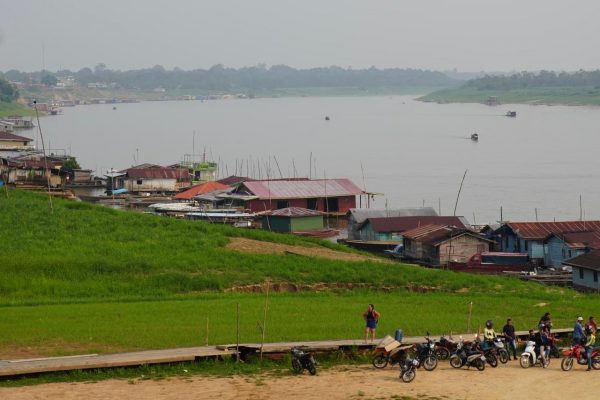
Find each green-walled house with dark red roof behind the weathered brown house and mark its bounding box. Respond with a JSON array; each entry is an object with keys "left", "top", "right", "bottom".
[{"left": 357, "top": 215, "right": 471, "bottom": 242}]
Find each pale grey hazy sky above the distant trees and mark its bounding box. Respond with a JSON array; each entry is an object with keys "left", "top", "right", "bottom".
[{"left": 0, "top": 0, "right": 600, "bottom": 71}]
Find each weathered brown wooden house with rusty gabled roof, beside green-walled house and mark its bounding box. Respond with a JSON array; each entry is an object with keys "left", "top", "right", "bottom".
[{"left": 403, "top": 225, "right": 492, "bottom": 266}]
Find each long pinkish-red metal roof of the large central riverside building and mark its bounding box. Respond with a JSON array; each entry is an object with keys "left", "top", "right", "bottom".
[{"left": 243, "top": 178, "right": 363, "bottom": 200}]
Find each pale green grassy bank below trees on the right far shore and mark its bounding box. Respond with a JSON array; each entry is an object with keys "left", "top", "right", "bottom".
[{"left": 418, "top": 86, "right": 600, "bottom": 106}]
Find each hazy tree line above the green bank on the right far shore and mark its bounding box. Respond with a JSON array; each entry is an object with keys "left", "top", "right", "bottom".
[{"left": 466, "top": 70, "right": 600, "bottom": 90}]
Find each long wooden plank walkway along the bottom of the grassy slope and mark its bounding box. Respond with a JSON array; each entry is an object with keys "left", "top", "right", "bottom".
[{"left": 0, "top": 329, "right": 572, "bottom": 378}]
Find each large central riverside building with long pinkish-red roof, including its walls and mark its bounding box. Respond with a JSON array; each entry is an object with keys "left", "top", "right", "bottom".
[{"left": 229, "top": 178, "right": 363, "bottom": 215}]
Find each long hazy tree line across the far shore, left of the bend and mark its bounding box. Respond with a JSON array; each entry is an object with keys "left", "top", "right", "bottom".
[{"left": 0, "top": 64, "right": 455, "bottom": 92}]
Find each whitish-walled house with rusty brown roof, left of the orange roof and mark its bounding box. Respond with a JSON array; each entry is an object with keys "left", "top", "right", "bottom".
[{"left": 106, "top": 164, "right": 190, "bottom": 193}]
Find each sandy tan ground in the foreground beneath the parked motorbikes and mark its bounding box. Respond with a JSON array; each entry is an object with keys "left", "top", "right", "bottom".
[{"left": 0, "top": 359, "right": 600, "bottom": 400}]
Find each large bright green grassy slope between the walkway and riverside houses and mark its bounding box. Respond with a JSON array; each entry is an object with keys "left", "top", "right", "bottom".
[{"left": 0, "top": 190, "right": 600, "bottom": 358}]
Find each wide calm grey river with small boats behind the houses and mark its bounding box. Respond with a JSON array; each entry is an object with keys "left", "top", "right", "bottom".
[{"left": 29, "top": 96, "right": 600, "bottom": 224}]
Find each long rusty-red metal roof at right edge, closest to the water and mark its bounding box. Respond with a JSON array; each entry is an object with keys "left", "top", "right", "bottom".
[{"left": 506, "top": 221, "right": 600, "bottom": 240}]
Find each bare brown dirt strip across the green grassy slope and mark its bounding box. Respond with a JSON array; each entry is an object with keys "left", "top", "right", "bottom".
[{"left": 225, "top": 238, "right": 388, "bottom": 262}]
